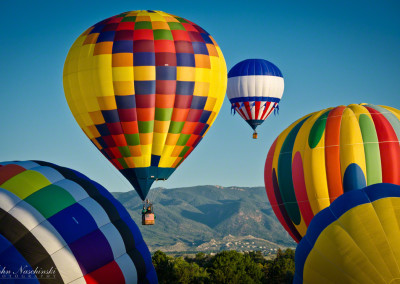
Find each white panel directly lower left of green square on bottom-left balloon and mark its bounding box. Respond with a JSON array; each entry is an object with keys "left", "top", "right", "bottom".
[{"left": 9, "top": 201, "right": 45, "bottom": 231}]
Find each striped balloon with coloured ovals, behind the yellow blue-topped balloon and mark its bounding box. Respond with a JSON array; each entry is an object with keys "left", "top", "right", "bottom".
[{"left": 264, "top": 104, "right": 400, "bottom": 242}]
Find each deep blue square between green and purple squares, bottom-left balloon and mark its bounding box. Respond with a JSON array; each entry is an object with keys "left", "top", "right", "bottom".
[{"left": 48, "top": 203, "right": 97, "bottom": 244}]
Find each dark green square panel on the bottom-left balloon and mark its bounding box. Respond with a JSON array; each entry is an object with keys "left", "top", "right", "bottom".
[{"left": 25, "top": 184, "right": 76, "bottom": 219}]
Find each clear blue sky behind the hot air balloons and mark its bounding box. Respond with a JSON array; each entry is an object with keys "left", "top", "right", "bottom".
[{"left": 0, "top": 0, "right": 400, "bottom": 195}]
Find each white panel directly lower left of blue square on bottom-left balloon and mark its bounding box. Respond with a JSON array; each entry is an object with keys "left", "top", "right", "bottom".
[{"left": 31, "top": 220, "right": 67, "bottom": 255}]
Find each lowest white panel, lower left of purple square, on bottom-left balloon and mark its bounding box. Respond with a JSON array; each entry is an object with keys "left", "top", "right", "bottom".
[{"left": 51, "top": 247, "right": 84, "bottom": 283}]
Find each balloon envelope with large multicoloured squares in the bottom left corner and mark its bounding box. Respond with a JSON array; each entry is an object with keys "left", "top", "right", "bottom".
[{"left": 0, "top": 161, "right": 157, "bottom": 284}]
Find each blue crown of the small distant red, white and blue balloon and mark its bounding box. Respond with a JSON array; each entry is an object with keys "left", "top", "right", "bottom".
[{"left": 228, "top": 59, "right": 283, "bottom": 78}]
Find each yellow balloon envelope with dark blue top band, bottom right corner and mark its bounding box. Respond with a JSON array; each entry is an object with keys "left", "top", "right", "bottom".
[{"left": 293, "top": 183, "right": 400, "bottom": 284}]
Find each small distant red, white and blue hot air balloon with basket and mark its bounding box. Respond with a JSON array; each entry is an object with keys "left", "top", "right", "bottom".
[{"left": 226, "top": 59, "right": 284, "bottom": 139}]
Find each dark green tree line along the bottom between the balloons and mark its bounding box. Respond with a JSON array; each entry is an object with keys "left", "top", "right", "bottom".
[{"left": 152, "top": 249, "right": 295, "bottom": 284}]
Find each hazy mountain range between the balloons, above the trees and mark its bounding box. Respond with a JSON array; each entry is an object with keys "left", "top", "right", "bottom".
[{"left": 113, "top": 185, "right": 296, "bottom": 252}]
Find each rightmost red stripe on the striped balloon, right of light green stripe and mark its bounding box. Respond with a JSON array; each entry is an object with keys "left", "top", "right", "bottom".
[{"left": 366, "top": 107, "right": 400, "bottom": 185}]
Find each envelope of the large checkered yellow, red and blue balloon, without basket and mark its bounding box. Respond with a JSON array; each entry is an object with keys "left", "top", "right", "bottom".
[{"left": 63, "top": 10, "right": 227, "bottom": 199}]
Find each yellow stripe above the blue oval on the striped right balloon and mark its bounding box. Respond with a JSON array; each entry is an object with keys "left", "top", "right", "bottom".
[{"left": 340, "top": 108, "right": 367, "bottom": 180}]
